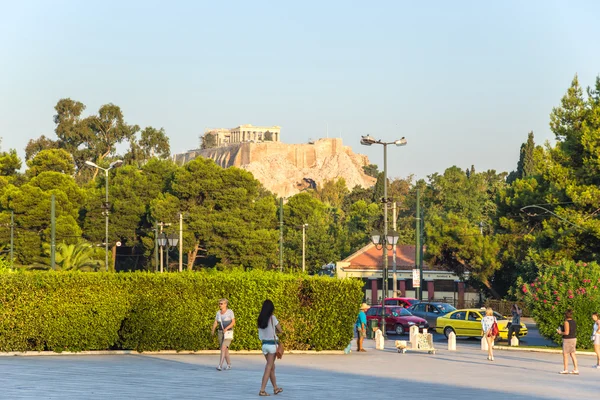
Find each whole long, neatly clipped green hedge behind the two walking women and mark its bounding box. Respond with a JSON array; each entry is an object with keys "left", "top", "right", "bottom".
[{"left": 0, "top": 271, "right": 362, "bottom": 352}]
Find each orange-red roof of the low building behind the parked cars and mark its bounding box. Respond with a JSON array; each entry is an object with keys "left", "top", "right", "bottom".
[{"left": 342, "top": 243, "right": 446, "bottom": 271}]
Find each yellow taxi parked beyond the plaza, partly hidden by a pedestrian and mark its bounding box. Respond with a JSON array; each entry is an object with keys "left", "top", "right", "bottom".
[{"left": 435, "top": 308, "right": 527, "bottom": 340}]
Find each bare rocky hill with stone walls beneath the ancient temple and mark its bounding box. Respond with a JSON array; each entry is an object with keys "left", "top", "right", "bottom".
[{"left": 174, "top": 138, "right": 376, "bottom": 197}]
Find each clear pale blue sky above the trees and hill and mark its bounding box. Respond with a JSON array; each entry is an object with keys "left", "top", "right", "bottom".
[{"left": 0, "top": 0, "right": 600, "bottom": 177}]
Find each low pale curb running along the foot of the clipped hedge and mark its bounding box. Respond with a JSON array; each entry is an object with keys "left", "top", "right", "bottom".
[{"left": 0, "top": 350, "right": 344, "bottom": 357}]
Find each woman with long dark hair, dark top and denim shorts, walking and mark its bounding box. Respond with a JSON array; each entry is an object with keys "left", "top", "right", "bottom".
[{"left": 258, "top": 300, "right": 283, "bottom": 396}]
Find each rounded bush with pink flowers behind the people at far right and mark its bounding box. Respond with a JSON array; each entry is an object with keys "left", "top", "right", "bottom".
[{"left": 519, "top": 261, "right": 600, "bottom": 348}]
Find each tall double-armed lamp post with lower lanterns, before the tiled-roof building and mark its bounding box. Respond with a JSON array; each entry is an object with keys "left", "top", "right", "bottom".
[{"left": 360, "top": 135, "right": 407, "bottom": 335}]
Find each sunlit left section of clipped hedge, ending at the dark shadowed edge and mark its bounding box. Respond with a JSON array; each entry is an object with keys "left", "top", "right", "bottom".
[{"left": 0, "top": 272, "right": 129, "bottom": 352}]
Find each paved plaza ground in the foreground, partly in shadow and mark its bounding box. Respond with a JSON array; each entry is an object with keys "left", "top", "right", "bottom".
[{"left": 0, "top": 341, "right": 600, "bottom": 400}]
